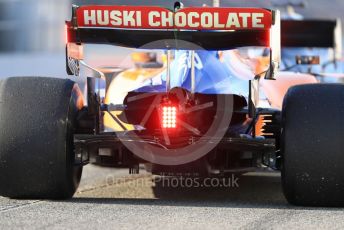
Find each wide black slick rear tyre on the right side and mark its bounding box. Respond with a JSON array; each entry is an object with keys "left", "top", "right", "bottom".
[{"left": 281, "top": 84, "right": 344, "bottom": 206}]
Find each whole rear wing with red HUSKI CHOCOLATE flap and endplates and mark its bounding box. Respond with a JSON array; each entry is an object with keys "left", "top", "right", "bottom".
[{"left": 66, "top": 5, "right": 280, "bottom": 73}]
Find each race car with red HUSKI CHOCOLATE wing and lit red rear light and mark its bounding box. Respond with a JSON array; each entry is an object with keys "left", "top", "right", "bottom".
[{"left": 0, "top": 2, "right": 344, "bottom": 206}]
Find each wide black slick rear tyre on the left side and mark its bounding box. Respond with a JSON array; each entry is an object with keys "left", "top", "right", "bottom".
[{"left": 0, "top": 77, "right": 83, "bottom": 199}]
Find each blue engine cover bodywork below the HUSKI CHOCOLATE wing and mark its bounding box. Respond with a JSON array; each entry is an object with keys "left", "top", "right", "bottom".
[{"left": 136, "top": 51, "right": 248, "bottom": 97}]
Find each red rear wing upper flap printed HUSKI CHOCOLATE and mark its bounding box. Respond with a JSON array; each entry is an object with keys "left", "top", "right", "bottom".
[{"left": 73, "top": 5, "right": 274, "bottom": 30}]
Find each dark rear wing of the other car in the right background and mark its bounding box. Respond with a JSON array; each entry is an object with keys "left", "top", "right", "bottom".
[{"left": 281, "top": 20, "right": 342, "bottom": 58}]
